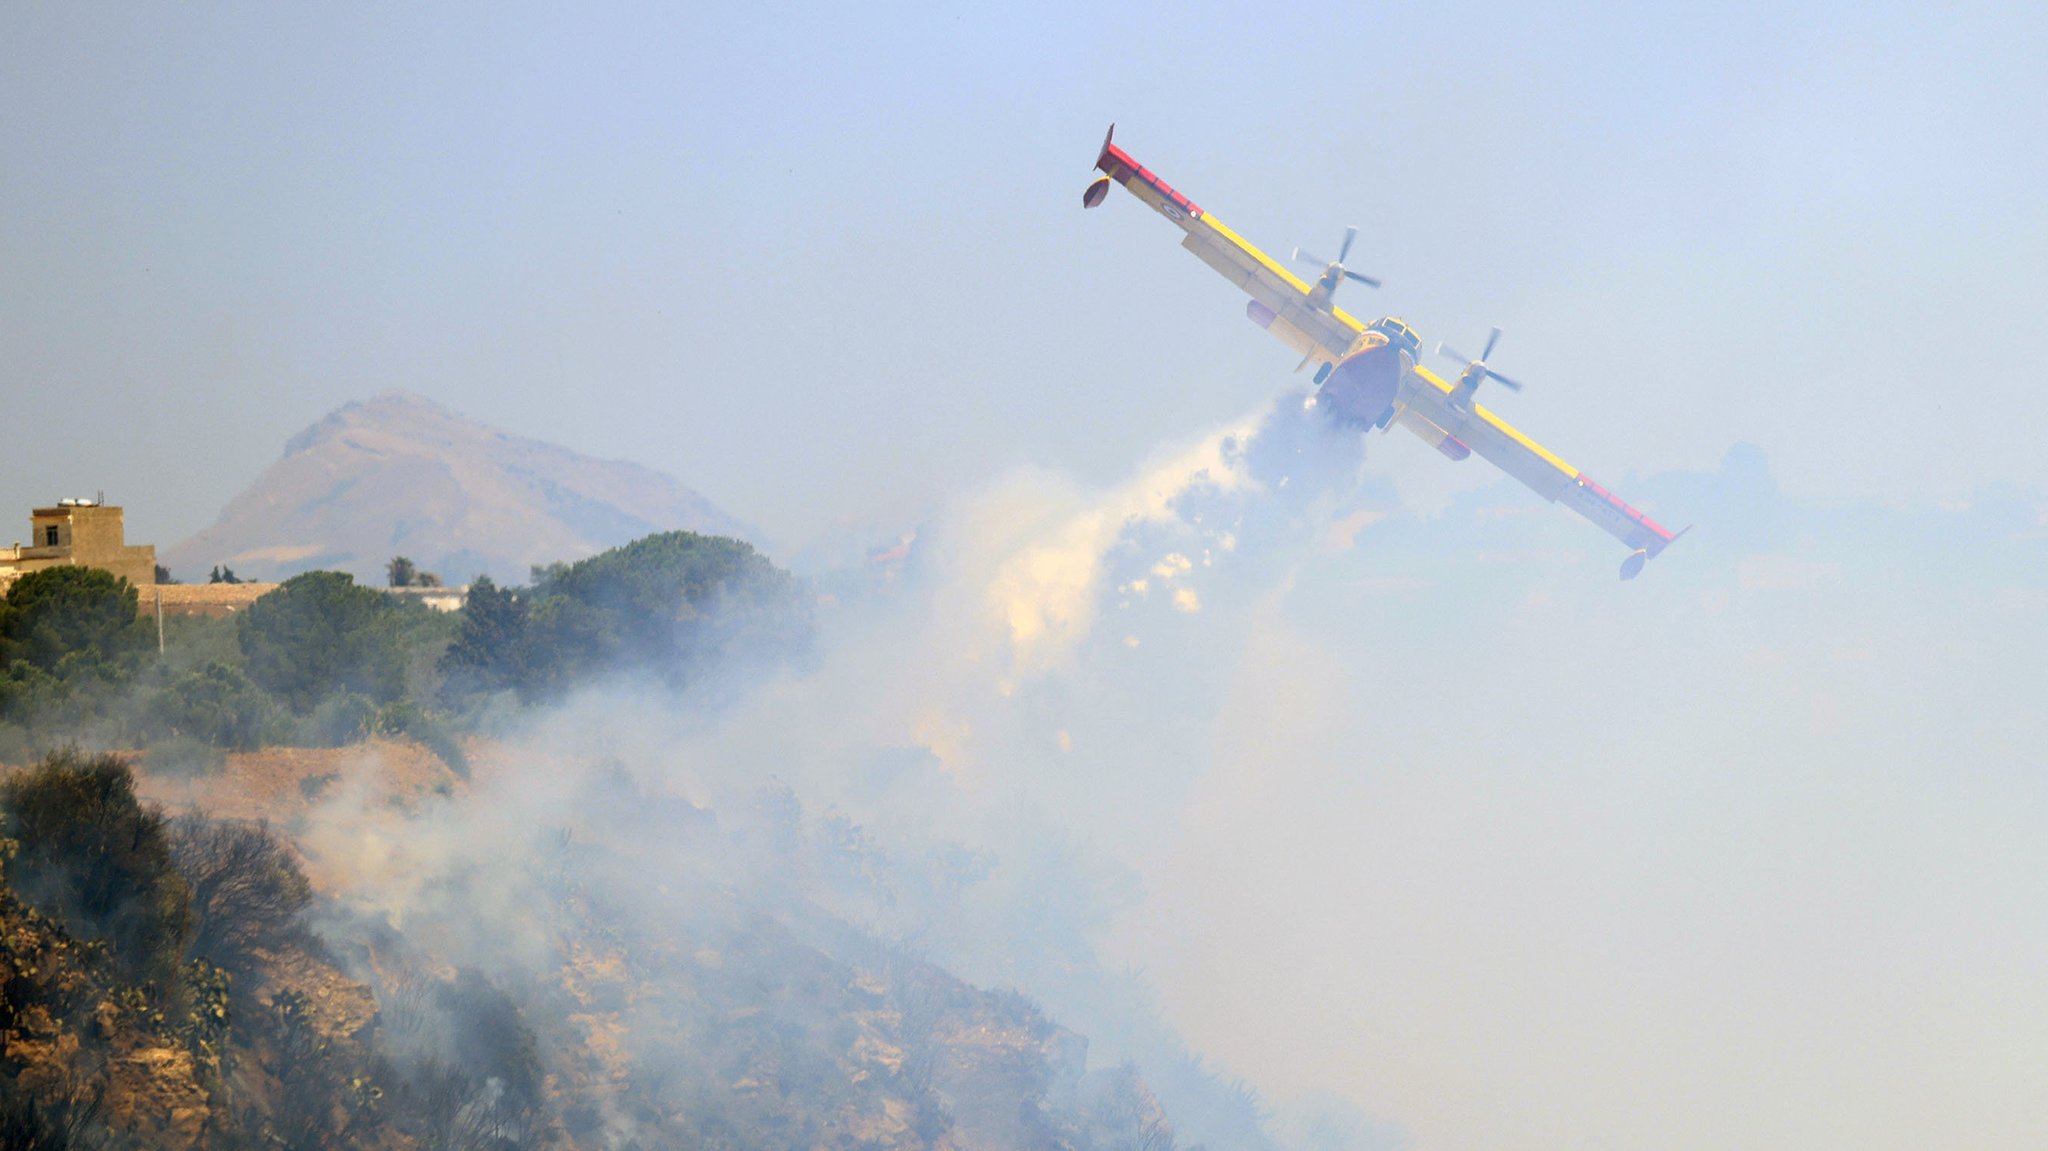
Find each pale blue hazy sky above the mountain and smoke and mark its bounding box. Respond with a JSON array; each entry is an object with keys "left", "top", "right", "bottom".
[{"left": 0, "top": 4, "right": 2048, "bottom": 547}]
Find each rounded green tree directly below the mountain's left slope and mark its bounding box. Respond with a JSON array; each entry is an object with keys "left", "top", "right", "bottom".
[{"left": 238, "top": 571, "right": 406, "bottom": 713}]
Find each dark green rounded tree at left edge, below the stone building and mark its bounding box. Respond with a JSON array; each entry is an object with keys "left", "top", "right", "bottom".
[{"left": 0, "top": 565, "right": 150, "bottom": 672}]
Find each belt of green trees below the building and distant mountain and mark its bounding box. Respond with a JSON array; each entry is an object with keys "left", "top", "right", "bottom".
[{"left": 0, "top": 532, "right": 809, "bottom": 772}]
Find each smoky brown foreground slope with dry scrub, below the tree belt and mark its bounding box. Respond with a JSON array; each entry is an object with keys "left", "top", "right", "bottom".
[{"left": 0, "top": 739, "right": 1174, "bottom": 1151}]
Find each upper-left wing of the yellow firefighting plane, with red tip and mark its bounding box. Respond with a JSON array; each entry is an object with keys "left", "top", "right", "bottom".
[{"left": 1092, "top": 125, "right": 1366, "bottom": 360}]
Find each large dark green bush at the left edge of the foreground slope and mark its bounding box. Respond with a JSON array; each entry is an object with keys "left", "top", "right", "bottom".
[{"left": 0, "top": 752, "right": 193, "bottom": 987}]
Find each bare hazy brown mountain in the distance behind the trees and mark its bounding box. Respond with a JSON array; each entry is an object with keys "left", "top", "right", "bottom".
[{"left": 164, "top": 391, "right": 745, "bottom": 584}]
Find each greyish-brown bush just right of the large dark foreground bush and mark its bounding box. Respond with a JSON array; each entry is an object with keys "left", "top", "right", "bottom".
[{"left": 170, "top": 815, "right": 313, "bottom": 975}]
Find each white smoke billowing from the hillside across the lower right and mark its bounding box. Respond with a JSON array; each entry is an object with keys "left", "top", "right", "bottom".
[{"left": 284, "top": 387, "right": 2048, "bottom": 1149}]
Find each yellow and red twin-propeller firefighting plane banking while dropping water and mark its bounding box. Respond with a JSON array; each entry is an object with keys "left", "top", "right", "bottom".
[{"left": 1081, "top": 125, "right": 1692, "bottom": 580}]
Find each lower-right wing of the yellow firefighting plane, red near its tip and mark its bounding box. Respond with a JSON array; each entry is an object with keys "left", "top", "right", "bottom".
[{"left": 1397, "top": 367, "right": 1686, "bottom": 580}]
